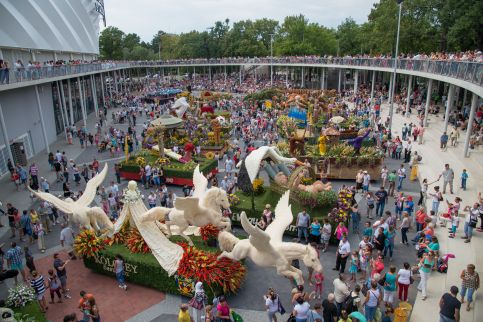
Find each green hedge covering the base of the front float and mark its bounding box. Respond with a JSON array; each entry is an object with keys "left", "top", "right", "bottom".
[{"left": 84, "top": 236, "right": 231, "bottom": 301}]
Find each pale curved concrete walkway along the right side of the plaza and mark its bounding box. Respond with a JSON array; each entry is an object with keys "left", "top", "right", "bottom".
[{"left": 382, "top": 104, "right": 483, "bottom": 322}]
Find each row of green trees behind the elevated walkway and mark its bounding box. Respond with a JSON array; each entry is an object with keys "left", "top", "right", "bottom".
[{"left": 99, "top": 0, "right": 483, "bottom": 60}]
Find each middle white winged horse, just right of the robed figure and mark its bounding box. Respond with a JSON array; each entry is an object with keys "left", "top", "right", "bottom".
[{"left": 143, "top": 166, "right": 231, "bottom": 245}]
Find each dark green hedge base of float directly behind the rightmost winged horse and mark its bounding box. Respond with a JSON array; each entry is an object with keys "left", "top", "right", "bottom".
[{"left": 231, "top": 187, "right": 334, "bottom": 236}]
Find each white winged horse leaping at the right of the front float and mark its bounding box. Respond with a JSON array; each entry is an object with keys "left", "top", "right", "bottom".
[{"left": 218, "top": 191, "right": 322, "bottom": 285}]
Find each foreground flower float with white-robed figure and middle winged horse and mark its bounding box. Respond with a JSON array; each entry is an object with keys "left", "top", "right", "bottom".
[{"left": 80, "top": 168, "right": 246, "bottom": 297}]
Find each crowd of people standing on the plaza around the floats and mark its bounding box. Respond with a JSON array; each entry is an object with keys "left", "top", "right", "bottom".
[{"left": 1, "top": 64, "right": 483, "bottom": 322}]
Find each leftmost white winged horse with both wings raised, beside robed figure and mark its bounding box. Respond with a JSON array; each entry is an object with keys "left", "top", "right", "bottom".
[{"left": 29, "top": 163, "right": 114, "bottom": 233}]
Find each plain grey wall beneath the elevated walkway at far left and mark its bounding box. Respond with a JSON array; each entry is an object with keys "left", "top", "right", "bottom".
[{"left": 0, "top": 84, "right": 57, "bottom": 155}]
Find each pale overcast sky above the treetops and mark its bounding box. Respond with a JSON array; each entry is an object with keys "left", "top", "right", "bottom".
[{"left": 104, "top": 0, "right": 378, "bottom": 41}]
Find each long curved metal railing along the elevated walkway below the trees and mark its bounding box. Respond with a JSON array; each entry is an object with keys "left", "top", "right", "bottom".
[{"left": 0, "top": 56, "right": 483, "bottom": 86}]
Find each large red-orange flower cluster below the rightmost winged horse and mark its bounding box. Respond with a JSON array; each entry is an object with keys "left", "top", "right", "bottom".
[{"left": 178, "top": 243, "right": 246, "bottom": 293}]
